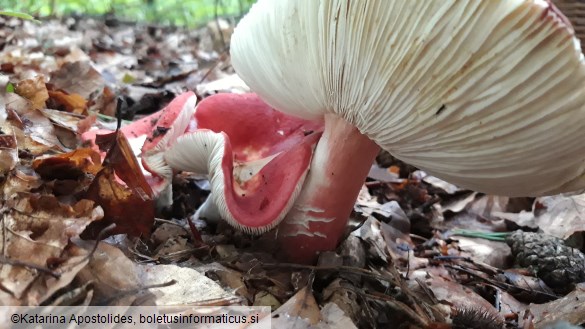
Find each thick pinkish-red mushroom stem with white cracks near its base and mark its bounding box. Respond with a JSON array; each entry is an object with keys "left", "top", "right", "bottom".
[{"left": 278, "top": 114, "right": 380, "bottom": 263}]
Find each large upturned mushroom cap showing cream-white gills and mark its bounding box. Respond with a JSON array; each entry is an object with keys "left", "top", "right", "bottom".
[{"left": 231, "top": 0, "right": 585, "bottom": 196}]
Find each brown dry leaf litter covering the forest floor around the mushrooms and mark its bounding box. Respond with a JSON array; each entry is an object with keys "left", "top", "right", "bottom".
[{"left": 0, "top": 13, "right": 585, "bottom": 328}]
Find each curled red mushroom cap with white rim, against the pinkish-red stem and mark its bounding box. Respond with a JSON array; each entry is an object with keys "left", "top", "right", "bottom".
[{"left": 142, "top": 94, "right": 322, "bottom": 234}]
